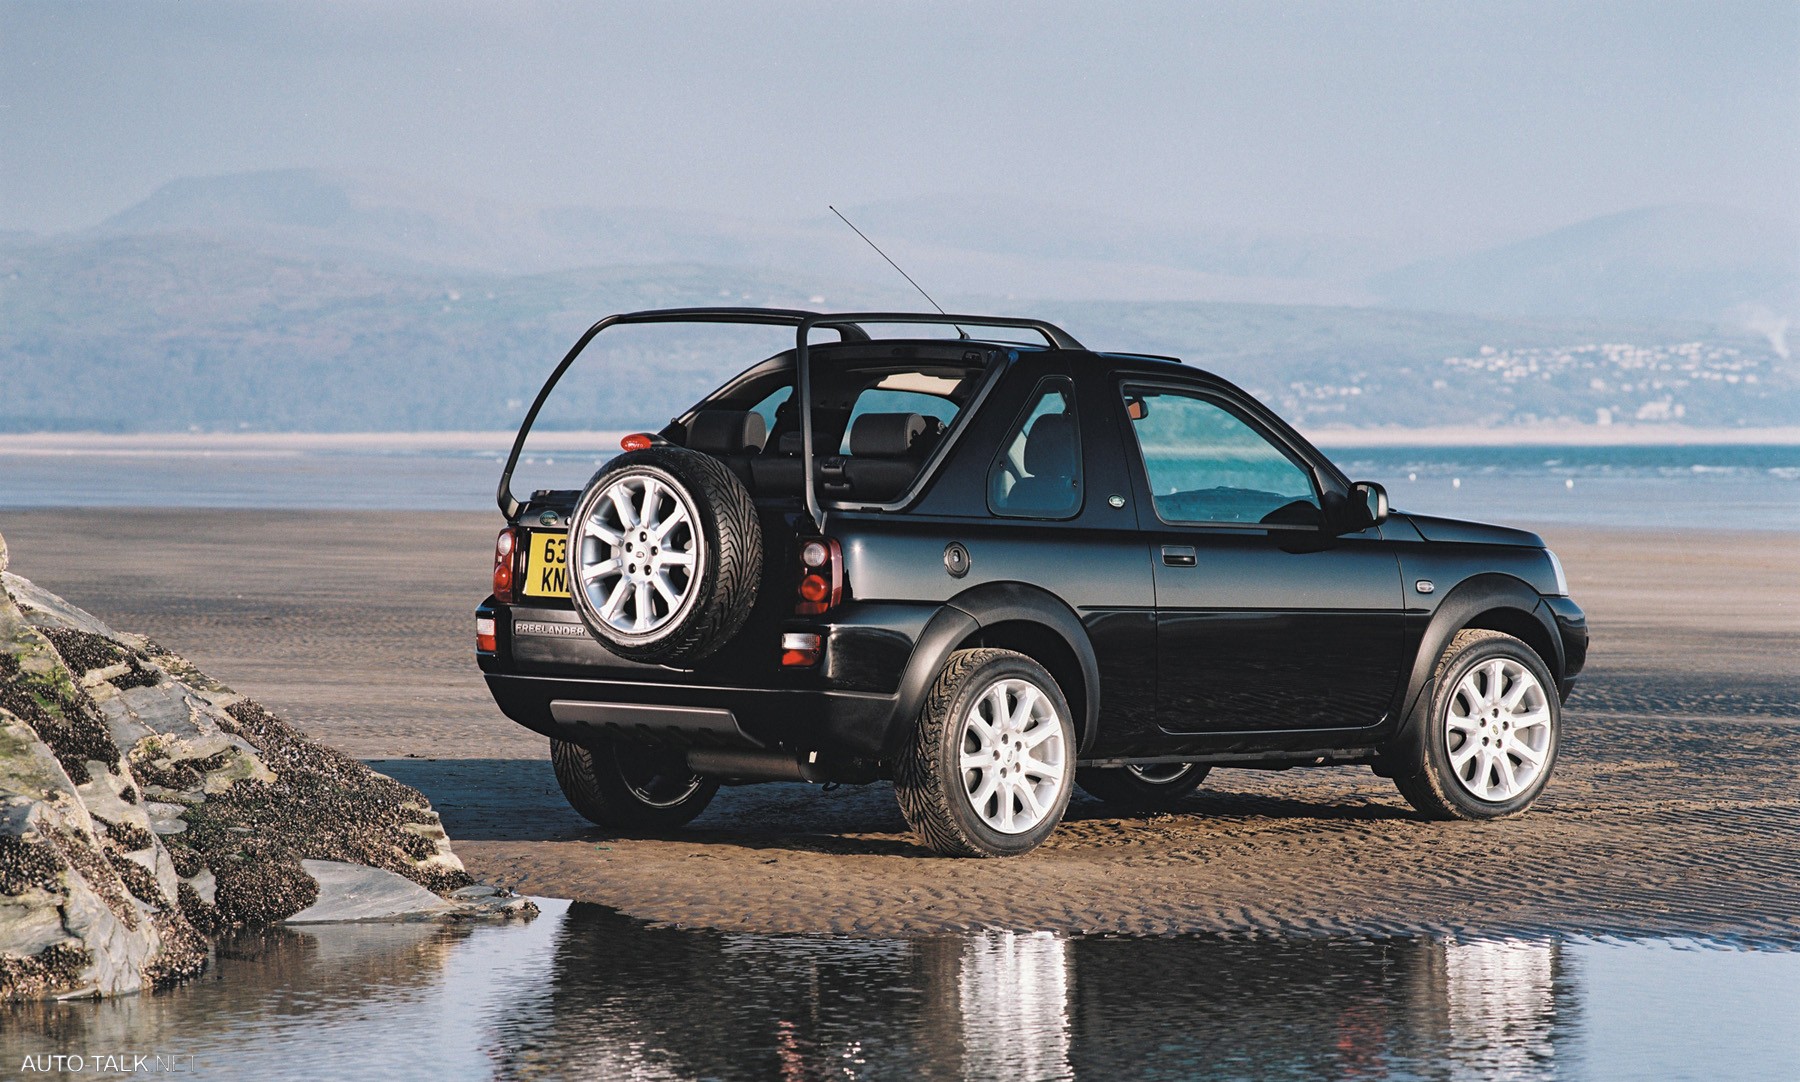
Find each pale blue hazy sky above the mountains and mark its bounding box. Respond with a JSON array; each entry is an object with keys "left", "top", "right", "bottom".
[{"left": 0, "top": 0, "right": 1800, "bottom": 248}]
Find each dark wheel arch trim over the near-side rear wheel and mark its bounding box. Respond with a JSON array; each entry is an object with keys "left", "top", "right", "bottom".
[{"left": 889, "top": 582, "right": 1100, "bottom": 751}]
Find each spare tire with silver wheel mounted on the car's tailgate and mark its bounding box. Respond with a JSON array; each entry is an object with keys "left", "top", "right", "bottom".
[{"left": 569, "top": 445, "right": 763, "bottom": 664}]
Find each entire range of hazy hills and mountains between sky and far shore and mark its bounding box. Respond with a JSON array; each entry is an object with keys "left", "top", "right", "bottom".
[{"left": 0, "top": 169, "right": 1800, "bottom": 430}]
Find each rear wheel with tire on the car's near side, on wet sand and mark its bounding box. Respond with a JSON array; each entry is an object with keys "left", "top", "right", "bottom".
[{"left": 895, "top": 648, "right": 1075, "bottom": 857}]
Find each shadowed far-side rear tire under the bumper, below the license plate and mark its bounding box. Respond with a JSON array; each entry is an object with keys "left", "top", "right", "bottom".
[{"left": 551, "top": 738, "right": 718, "bottom": 830}]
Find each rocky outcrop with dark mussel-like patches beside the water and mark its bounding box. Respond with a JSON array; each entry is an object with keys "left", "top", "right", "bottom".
[{"left": 0, "top": 525, "right": 533, "bottom": 1001}]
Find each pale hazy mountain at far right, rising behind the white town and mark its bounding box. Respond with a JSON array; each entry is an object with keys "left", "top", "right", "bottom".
[{"left": 1372, "top": 205, "right": 1800, "bottom": 319}]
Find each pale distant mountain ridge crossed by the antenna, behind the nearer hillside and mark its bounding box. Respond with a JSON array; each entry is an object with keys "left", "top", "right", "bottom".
[{"left": 81, "top": 169, "right": 1391, "bottom": 306}]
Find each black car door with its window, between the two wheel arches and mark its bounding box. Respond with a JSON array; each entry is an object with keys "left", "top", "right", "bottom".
[{"left": 1120, "top": 383, "right": 1404, "bottom": 735}]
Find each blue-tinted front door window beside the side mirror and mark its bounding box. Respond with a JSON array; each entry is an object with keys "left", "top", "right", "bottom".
[{"left": 1125, "top": 387, "right": 1323, "bottom": 526}]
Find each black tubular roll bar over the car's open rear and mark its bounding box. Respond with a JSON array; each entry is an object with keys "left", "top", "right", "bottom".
[{"left": 495, "top": 308, "right": 1082, "bottom": 529}]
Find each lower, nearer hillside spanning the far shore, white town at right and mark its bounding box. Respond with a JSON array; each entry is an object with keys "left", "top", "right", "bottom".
[{"left": 0, "top": 232, "right": 1800, "bottom": 430}]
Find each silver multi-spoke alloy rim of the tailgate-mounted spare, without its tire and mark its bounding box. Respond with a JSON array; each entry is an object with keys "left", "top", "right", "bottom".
[{"left": 572, "top": 472, "right": 704, "bottom": 636}]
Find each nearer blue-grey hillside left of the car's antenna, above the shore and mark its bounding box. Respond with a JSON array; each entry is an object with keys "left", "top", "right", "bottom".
[{"left": 0, "top": 234, "right": 900, "bottom": 430}]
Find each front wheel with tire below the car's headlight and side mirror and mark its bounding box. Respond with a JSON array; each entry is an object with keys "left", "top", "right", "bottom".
[{"left": 1395, "top": 630, "right": 1562, "bottom": 819}]
